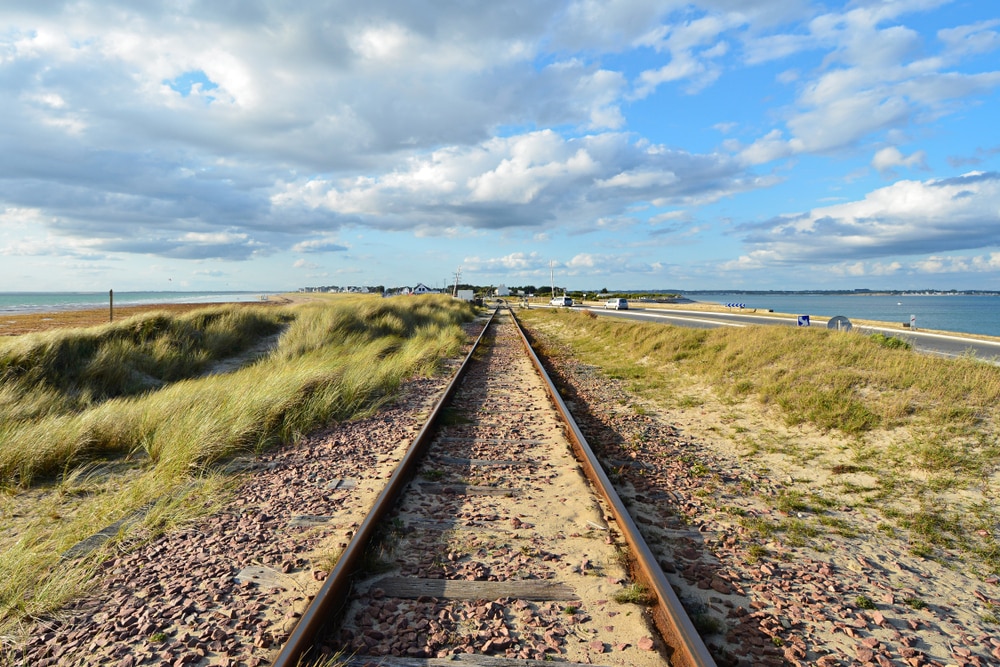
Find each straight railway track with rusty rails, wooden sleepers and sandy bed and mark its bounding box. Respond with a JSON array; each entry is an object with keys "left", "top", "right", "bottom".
[{"left": 274, "top": 310, "right": 714, "bottom": 667}]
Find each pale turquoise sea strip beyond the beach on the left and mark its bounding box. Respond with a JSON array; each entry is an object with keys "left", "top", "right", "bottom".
[{"left": 0, "top": 292, "right": 278, "bottom": 314}]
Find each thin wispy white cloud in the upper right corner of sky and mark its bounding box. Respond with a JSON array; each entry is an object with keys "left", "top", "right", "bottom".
[{"left": 742, "top": 0, "right": 1000, "bottom": 166}]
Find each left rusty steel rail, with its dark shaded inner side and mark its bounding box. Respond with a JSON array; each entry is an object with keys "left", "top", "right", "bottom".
[{"left": 272, "top": 309, "right": 499, "bottom": 667}]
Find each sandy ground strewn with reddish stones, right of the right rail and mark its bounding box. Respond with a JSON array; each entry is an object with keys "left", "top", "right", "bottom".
[{"left": 524, "top": 314, "right": 1000, "bottom": 667}]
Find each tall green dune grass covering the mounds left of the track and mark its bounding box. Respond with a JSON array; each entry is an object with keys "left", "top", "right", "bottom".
[{"left": 0, "top": 297, "right": 473, "bottom": 633}]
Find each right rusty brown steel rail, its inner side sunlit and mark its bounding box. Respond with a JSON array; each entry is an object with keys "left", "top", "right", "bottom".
[{"left": 510, "top": 310, "right": 716, "bottom": 667}]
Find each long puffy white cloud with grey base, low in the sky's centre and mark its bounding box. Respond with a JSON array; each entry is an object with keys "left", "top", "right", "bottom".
[{"left": 272, "top": 130, "right": 752, "bottom": 230}]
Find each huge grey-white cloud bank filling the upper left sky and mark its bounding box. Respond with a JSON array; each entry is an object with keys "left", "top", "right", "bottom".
[{"left": 0, "top": 2, "right": 644, "bottom": 258}]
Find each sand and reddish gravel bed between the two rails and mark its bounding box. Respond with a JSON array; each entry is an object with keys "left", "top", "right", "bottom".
[{"left": 334, "top": 315, "right": 667, "bottom": 667}]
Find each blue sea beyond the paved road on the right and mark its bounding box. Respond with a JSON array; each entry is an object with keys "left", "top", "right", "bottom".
[{"left": 685, "top": 292, "right": 1000, "bottom": 336}]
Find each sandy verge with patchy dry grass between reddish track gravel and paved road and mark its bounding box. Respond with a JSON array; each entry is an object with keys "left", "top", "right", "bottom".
[{"left": 519, "top": 309, "right": 1000, "bottom": 573}]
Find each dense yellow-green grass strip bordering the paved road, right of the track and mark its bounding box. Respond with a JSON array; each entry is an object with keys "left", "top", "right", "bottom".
[{"left": 523, "top": 310, "right": 1000, "bottom": 444}]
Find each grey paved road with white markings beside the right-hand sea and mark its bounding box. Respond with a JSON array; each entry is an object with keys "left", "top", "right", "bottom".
[{"left": 544, "top": 304, "right": 1000, "bottom": 363}]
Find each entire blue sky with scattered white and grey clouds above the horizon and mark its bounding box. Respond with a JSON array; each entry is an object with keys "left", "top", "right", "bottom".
[{"left": 0, "top": 0, "right": 1000, "bottom": 292}]
